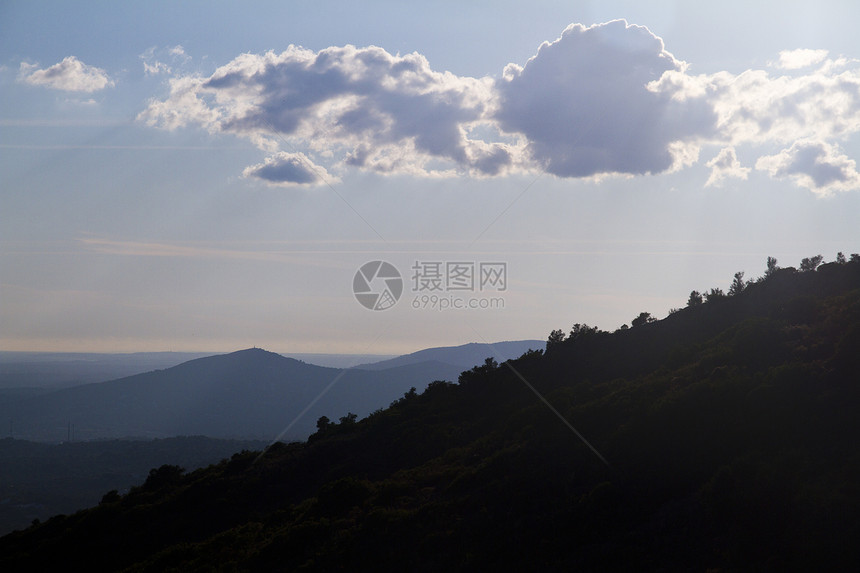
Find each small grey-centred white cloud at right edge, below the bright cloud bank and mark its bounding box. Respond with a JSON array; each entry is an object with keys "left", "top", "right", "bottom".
[{"left": 756, "top": 140, "right": 860, "bottom": 196}]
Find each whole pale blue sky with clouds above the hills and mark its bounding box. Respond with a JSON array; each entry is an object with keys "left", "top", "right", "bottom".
[{"left": 0, "top": 0, "right": 860, "bottom": 354}]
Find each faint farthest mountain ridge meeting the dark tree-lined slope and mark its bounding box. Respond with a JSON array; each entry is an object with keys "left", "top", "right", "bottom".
[{"left": 355, "top": 340, "right": 546, "bottom": 370}]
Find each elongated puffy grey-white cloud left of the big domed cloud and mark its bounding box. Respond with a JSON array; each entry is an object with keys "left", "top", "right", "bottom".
[{"left": 139, "top": 46, "right": 510, "bottom": 174}]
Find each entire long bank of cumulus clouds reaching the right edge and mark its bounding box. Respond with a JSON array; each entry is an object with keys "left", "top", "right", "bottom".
[{"left": 138, "top": 20, "right": 860, "bottom": 194}]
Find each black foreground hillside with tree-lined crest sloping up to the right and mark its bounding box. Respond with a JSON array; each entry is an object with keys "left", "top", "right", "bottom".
[{"left": 0, "top": 261, "right": 860, "bottom": 571}]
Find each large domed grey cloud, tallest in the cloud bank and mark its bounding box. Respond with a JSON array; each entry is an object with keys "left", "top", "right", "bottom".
[{"left": 495, "top": 20, "right": 716, "bottom": 177}]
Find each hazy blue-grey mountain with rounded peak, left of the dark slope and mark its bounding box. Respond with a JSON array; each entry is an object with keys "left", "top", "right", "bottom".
[{"left": 0, "top": 349, "right": 460, "bottom": 441}]
